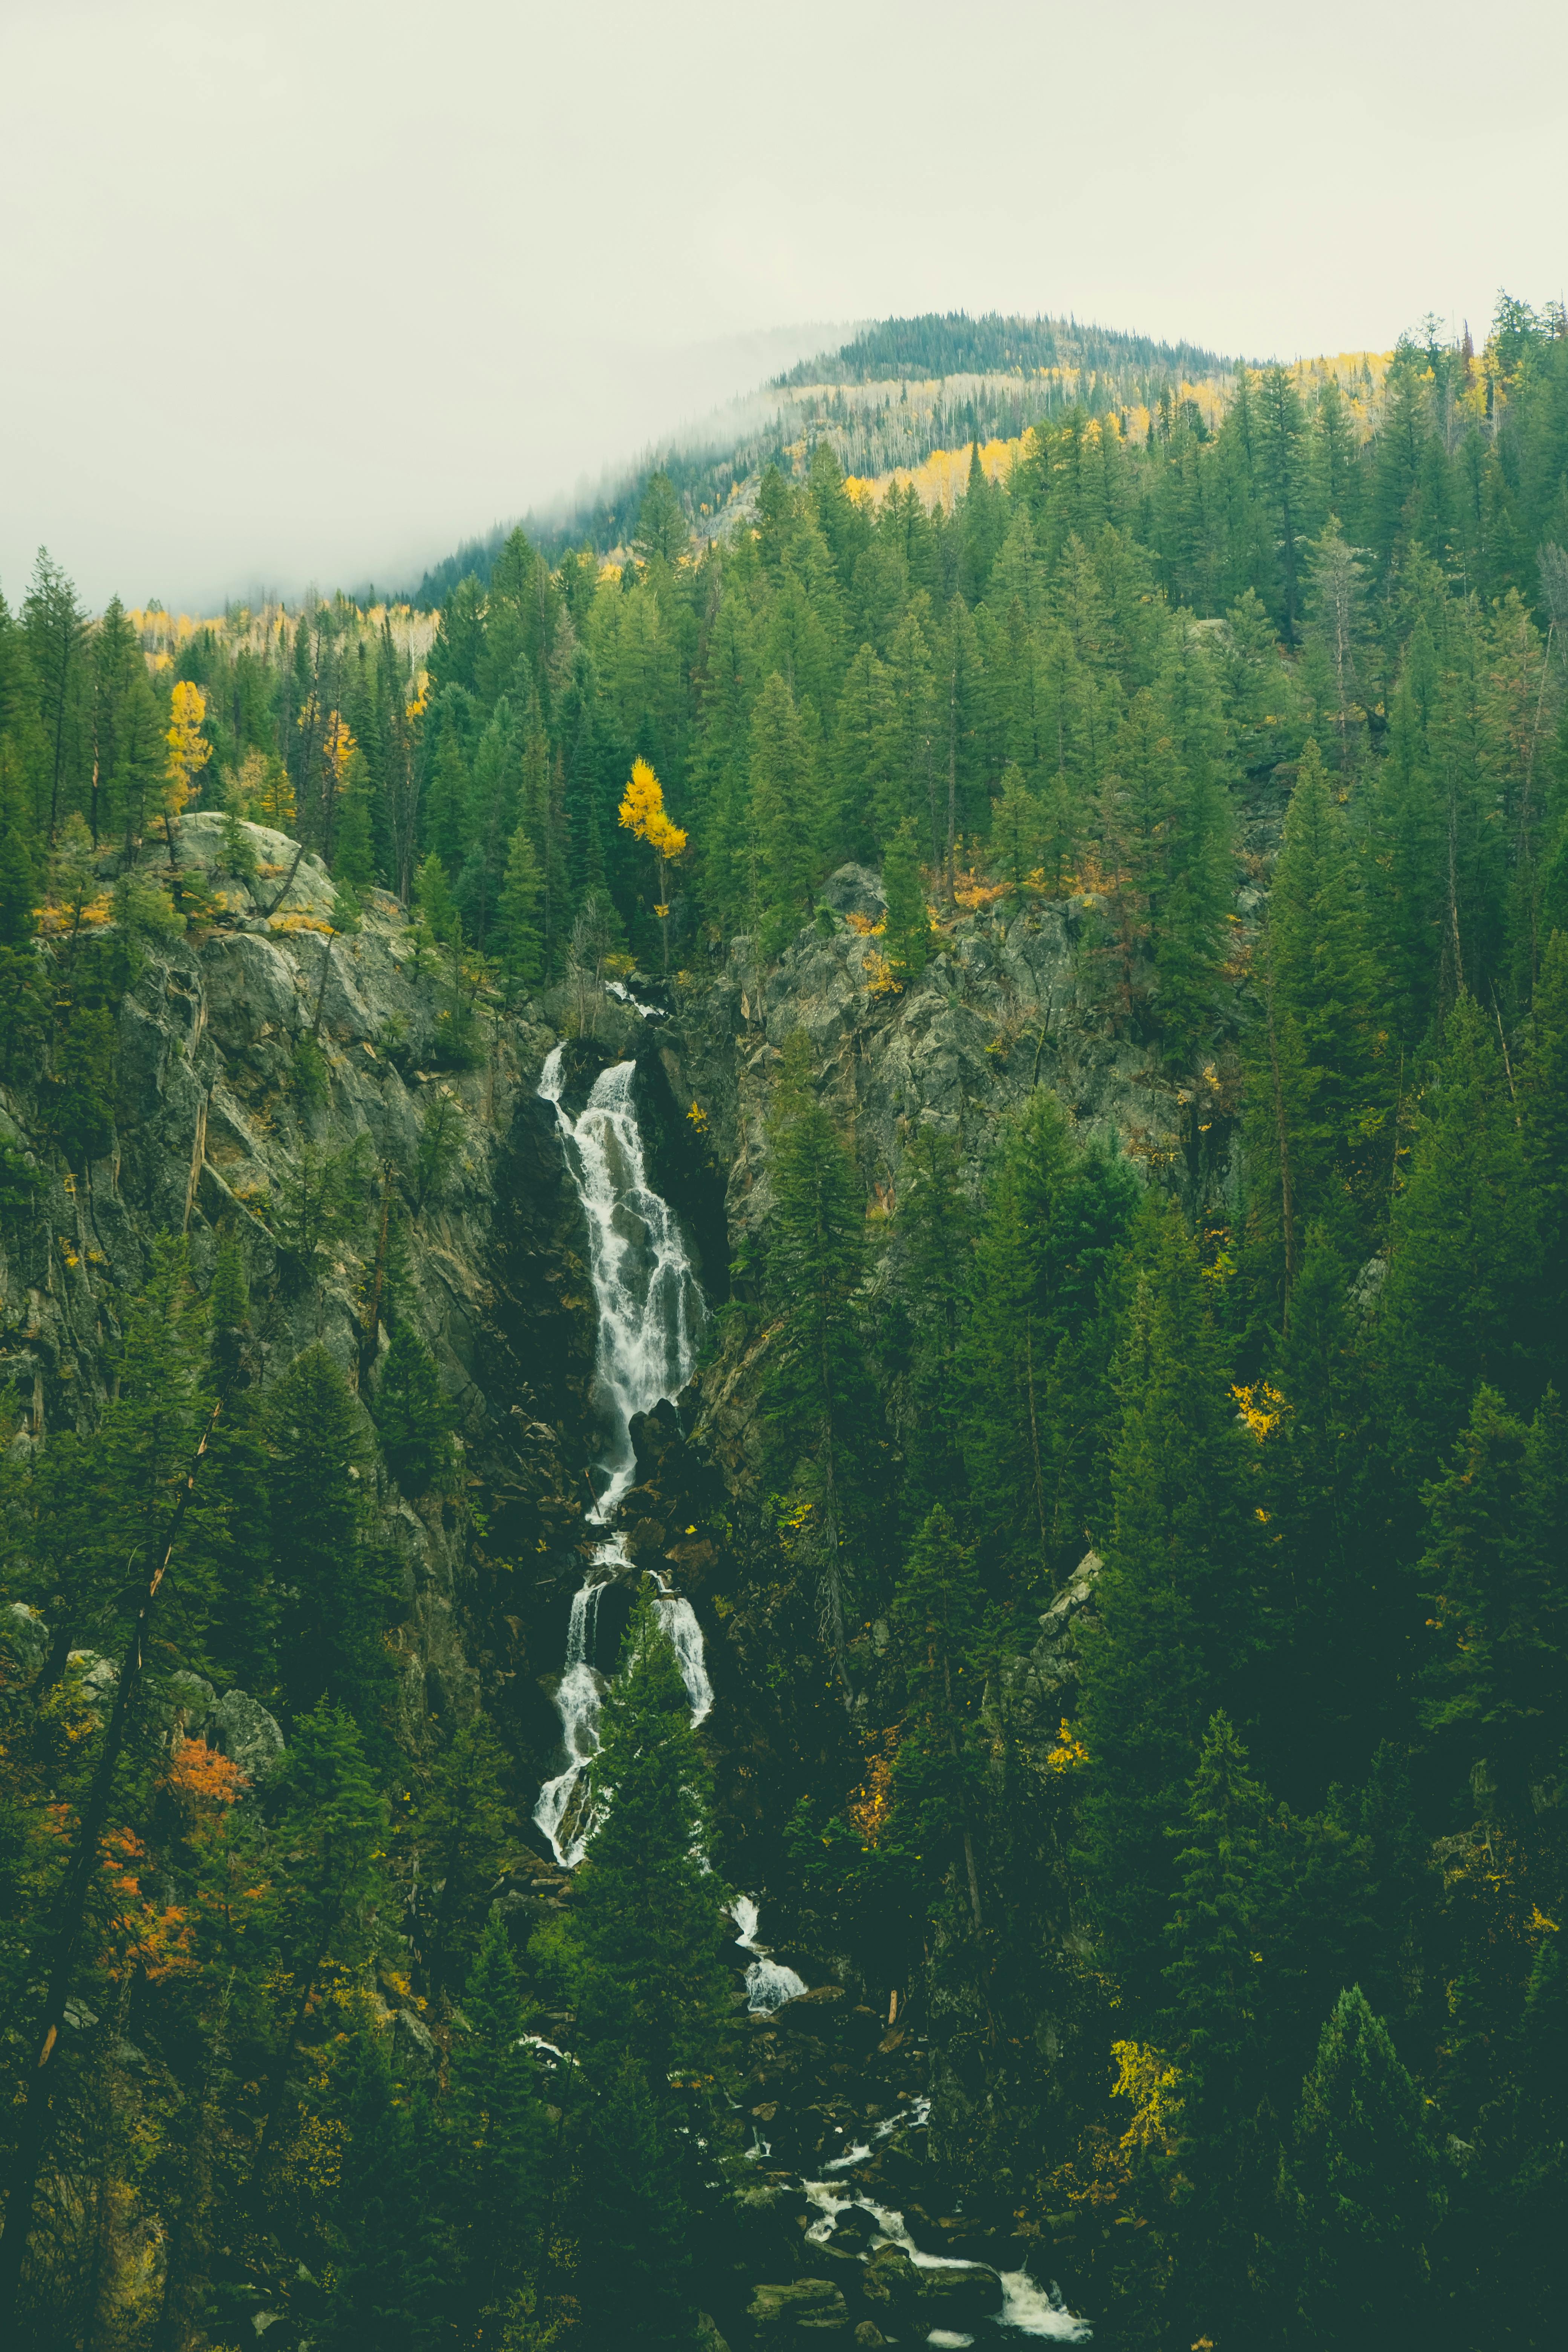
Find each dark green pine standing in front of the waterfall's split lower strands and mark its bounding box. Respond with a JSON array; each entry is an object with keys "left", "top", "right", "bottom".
[{"left": 569, "top": 1590, "right": 724, "bottom": 2096}]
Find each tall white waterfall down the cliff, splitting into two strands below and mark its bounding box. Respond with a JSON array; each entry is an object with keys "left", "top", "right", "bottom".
[{"left": 534, "top": 1044, "right": 712, "bottom": 1870}]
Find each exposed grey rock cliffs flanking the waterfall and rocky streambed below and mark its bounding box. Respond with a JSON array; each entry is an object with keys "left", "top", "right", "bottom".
[{"left": 0, "top": 816, "right": 1232, "bottom": 2343}]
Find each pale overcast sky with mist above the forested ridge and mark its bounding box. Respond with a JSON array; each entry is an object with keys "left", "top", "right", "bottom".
[{"left": 0, "top": 0, "right": 1568, "bottom": 609}]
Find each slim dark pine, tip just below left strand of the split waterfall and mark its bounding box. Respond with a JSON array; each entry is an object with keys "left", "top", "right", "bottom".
[{"left": 451, "top": 1912, "right": 548, "bottom": 2345}]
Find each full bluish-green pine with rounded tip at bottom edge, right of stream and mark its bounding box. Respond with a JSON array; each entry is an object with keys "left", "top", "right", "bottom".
[{"left": 1291, "top": 1985, "right": 1443, "bottom": 2352}]
